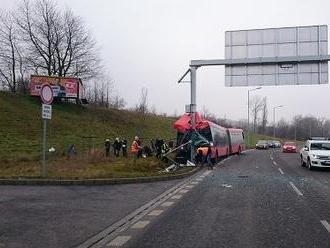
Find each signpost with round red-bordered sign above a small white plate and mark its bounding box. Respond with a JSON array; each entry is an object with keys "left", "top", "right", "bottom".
[{"left": 40, "top": 84, "right": 54, "bottom": 177}]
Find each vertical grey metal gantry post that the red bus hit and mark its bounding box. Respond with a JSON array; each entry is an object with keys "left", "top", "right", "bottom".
[{"left": 190, "top": 66, "right": 197, "bottom": 161}]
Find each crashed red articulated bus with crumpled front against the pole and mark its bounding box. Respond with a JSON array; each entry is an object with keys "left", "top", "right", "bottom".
[{"left": 174, "top": 113, "right": 245, "bottom": 158}]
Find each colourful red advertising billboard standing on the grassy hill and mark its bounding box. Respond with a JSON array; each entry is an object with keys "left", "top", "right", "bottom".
[{"left": 30, "top": 76, "right": 80, "bottom": 98}]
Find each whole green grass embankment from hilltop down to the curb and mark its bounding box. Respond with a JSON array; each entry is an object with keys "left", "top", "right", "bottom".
[{"left": 0, "top": 92, "right": 183, "bottom": 178}]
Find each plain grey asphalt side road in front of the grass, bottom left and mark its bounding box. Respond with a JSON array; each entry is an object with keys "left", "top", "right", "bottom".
[{"left": 0, "top": 180, "right": 178, "bottom": 248}]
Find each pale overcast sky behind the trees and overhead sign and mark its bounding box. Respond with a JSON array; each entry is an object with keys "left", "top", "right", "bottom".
[{"left": 0, "top": 0, "right": 330, "bottom": 121}]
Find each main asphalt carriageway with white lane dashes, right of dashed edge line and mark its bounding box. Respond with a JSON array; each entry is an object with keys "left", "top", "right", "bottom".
[{"left": 107, "top": 150, "right": 330, "bottom": 248}]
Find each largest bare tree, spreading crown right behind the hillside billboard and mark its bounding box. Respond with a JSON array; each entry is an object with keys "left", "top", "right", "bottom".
[{"left": 16, "top": 0, "right": 101, "bottom": 79}]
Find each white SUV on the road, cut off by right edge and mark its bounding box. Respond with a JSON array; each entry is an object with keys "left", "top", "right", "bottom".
[{"left": 300, "top": 140, "right": 330, "bottom": 170}]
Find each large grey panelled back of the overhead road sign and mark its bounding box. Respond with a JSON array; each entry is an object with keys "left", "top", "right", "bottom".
[{"left": 225, "top": 25, "right": 328, "bottom": 86}]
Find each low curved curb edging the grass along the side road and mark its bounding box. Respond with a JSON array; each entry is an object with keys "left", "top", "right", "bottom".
[{"left": 0, "top": 167, "right": 201, "bottom": 186}]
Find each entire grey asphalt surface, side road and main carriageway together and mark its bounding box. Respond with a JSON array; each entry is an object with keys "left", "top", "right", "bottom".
[{"left": 0, "top": 150, "right": 330, "bottom": 248}]
